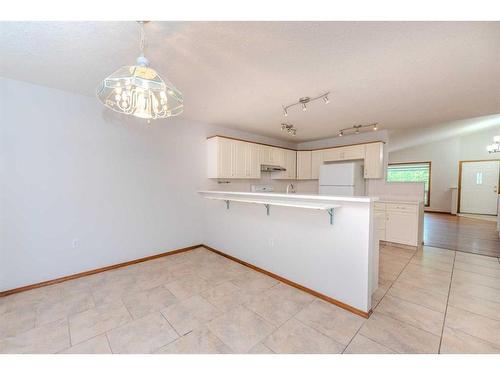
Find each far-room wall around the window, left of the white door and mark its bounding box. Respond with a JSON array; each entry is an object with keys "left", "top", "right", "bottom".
[{"left": 389, "top": 125, "right": 500, "bottom": 212}]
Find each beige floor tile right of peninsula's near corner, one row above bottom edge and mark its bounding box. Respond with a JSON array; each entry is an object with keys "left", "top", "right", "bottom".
[{"left": 376, "top": 295, "right": 444, "bottom": 336}]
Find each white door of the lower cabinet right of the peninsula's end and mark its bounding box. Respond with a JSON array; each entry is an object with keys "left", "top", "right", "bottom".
[{"left": 385, "top": 211, "right": 418, "bottom": 246}]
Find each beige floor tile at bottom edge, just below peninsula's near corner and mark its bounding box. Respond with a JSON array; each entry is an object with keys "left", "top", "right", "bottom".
[{"left": 360, "top": 312, "right": 440, "bottom": 354}]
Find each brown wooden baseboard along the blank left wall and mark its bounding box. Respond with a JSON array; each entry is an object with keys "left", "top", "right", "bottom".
[{"left": 0, "top": 245, "right": 203, "bottom": 297}]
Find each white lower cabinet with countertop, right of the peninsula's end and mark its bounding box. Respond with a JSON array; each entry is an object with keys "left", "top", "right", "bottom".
[{"left": 374, "top": 202, "right": 423, "bottom": 246}]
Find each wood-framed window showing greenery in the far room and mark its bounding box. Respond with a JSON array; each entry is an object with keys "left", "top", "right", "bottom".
[{"left": 387, "top": 161, "right": 431, "bottom": 207}]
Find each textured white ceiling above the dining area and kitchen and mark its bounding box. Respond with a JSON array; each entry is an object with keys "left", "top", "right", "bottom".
[{"left": 0, "top": 22, "right": 500, "bottom": 141}]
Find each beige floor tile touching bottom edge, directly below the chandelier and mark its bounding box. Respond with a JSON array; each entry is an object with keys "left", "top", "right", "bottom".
[{"left": 106, "top": 312, "right": 179, "bottom": 354}]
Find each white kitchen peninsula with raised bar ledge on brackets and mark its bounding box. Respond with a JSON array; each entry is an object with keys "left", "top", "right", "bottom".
[{"left": 199, "top": 191, "right": 378, "bottom": 317}]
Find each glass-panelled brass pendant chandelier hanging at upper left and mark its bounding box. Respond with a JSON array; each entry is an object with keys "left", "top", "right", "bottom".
[{"left": 96, "top": 21, "right": 184, "bottom": 122}]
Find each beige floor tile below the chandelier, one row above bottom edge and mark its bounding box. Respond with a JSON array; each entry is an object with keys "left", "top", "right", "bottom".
[{"left": 122, "top": 286, "right": 178, "bottom": 319}]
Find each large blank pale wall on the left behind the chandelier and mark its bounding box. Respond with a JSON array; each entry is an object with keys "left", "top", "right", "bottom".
[{"left": 0, "top": 79, "right": 288, "bottom": 290}]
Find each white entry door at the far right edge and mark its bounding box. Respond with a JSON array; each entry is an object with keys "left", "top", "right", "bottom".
[{"left": 460, "top": 160, "right": 500, "bottom": 215}]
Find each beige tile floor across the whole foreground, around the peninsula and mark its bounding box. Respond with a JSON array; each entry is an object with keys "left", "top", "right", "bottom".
[{"left": 0, "top": 246, "right": 500, "bottom": 353}]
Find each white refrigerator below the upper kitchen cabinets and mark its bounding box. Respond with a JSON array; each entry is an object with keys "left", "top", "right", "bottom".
[{"left": 319, "top": 162, "right": 365, "bottom": 196}]
